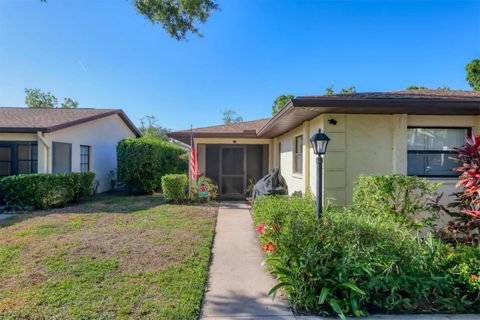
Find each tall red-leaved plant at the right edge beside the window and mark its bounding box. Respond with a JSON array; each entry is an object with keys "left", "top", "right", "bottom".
[{"left": 440, "top": 133, "right": 480, "bottom": 246}]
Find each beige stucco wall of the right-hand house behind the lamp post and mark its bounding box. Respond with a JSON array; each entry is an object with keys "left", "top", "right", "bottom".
[{"left": 274, "top": 114, "right": 480, "bottom": 205}]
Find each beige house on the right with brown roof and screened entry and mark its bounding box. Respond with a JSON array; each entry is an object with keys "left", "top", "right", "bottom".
[{"left": 171, "top": 90, "right": 480, "bottom": 205}]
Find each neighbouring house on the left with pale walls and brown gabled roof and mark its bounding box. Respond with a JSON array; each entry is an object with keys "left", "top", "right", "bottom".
[{"left": 0, "top": 108, "right": 141, "bottom": 192}]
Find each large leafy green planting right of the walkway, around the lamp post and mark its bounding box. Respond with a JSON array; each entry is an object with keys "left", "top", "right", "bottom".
[{"left": 253, "top": 196, "right": 480, "bottom": 317}]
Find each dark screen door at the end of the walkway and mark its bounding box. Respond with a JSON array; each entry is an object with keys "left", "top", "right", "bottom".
[{"left": 219, "top": 146, "right": 247, "bottom": 199}]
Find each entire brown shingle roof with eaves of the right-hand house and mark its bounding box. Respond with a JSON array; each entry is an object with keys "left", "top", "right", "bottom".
[{"left": 171, "top": 90, "right": 480, "bottom": 143}]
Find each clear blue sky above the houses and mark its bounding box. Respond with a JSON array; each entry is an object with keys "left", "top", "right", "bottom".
[{"left": 0, "top": 0, "right": 480, "bottom": 129}]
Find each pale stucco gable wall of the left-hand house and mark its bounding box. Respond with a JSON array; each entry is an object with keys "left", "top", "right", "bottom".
[{"left": 38, "top": 115, "right": 135, "bottom": 192}]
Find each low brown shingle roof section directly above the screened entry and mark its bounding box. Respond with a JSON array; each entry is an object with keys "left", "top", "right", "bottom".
[{"left": 169, "top": 118, "right": 270, "bottom": 143}]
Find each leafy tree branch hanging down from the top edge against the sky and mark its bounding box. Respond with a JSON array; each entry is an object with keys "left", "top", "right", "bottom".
[{"left": 133, "top": 0, "right": 219, "bottom": 40}]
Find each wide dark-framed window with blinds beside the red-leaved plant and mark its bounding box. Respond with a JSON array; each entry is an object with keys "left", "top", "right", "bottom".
[{"left": 407, "top": 128, "right": 470, "bottom": 177}]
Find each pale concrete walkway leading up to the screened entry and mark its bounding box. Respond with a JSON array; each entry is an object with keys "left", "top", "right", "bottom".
[{"left": 201, "top": 203, "right": 480, "bottom": 320}]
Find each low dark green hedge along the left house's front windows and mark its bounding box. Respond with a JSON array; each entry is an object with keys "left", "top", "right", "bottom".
[{"left": 0, "top": 172, "right": 95, "bottom": 209}]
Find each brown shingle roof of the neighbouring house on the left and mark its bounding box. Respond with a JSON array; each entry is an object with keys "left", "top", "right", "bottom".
[{"left": 0, "top": 107, "right": 141, "bottom": 136}]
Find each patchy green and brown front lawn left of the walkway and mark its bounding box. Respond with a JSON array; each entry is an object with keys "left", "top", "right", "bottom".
[{"left": 0, "top": 196, "right": 217, "bottom": 319}]
